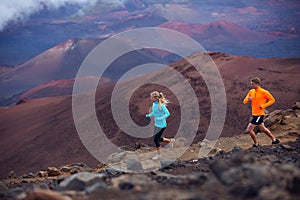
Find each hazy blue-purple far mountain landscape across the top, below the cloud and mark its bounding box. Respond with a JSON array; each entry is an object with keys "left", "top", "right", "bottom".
[{"left": 0, "top": 0, "right": 300, "bottom": 65}]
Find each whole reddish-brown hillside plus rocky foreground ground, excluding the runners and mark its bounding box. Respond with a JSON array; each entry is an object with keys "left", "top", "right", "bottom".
[{"left": 0, "top": 52, "right": 300, "bottom": 199}]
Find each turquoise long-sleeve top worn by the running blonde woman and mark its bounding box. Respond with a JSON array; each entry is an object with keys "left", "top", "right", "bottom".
[{"left": 146, "top": 101, "right": 170, "bottom": 128}]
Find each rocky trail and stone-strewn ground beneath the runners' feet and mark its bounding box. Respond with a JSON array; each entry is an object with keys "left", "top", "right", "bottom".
[{"left": 0, "top": 102, "right": 300, "bottom": 200}]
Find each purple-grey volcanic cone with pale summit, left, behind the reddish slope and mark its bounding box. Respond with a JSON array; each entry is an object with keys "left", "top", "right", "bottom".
[{"left": 0, "top": 39, "right": 163, "bottom": 101}]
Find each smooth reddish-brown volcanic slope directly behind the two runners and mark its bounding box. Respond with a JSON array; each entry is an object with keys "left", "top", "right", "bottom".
[{"left": 0, "top": 52, "right": 300, "bottom": 177}]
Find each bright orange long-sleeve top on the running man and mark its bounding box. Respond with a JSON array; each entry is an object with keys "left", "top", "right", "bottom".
[{"left": 244, "top": 87, "right": 275, "bottom": 116}]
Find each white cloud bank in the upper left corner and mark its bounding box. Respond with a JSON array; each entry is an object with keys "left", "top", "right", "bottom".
[{"left": 0, "top": 0, "right": 123, "bottom": 31}]
